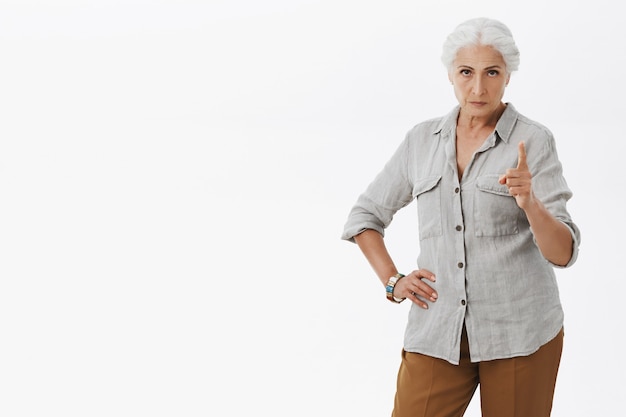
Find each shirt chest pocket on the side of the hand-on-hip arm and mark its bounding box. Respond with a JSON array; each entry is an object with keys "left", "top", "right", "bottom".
[{"left": 413, "top": 176, "right": 443, "bottom": 240}]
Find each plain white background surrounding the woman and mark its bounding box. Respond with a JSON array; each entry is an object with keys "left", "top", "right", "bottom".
[{"left": 0, "top": 0, "right": 626, "bottom": 417}]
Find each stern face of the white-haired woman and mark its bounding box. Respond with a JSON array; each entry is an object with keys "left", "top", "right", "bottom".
[{"left": 448, "top": 45, "right": 511, "bottom": 117}]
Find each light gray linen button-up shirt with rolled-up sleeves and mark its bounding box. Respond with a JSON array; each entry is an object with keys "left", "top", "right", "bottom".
[{"left": 342, "top": 103, "right": 580, "bottom": 364}]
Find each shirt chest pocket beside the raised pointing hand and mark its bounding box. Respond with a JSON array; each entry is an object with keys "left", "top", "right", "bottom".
[{"left": 474, "top": 174, "right": 522, "bottom": 236}]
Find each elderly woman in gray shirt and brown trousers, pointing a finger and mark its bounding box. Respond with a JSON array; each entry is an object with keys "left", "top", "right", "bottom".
[{"left": 342, "top": 18, "right": 580, "bottom": 417}]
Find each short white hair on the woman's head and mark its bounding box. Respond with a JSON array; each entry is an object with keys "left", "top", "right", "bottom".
[{"left": 441, "top": 17, "right": 519, "bottom": 74}]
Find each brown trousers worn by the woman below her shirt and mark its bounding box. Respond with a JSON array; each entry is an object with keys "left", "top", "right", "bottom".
[{"left": 392, "top": 328, "right": 563, "bottom": 417}]
